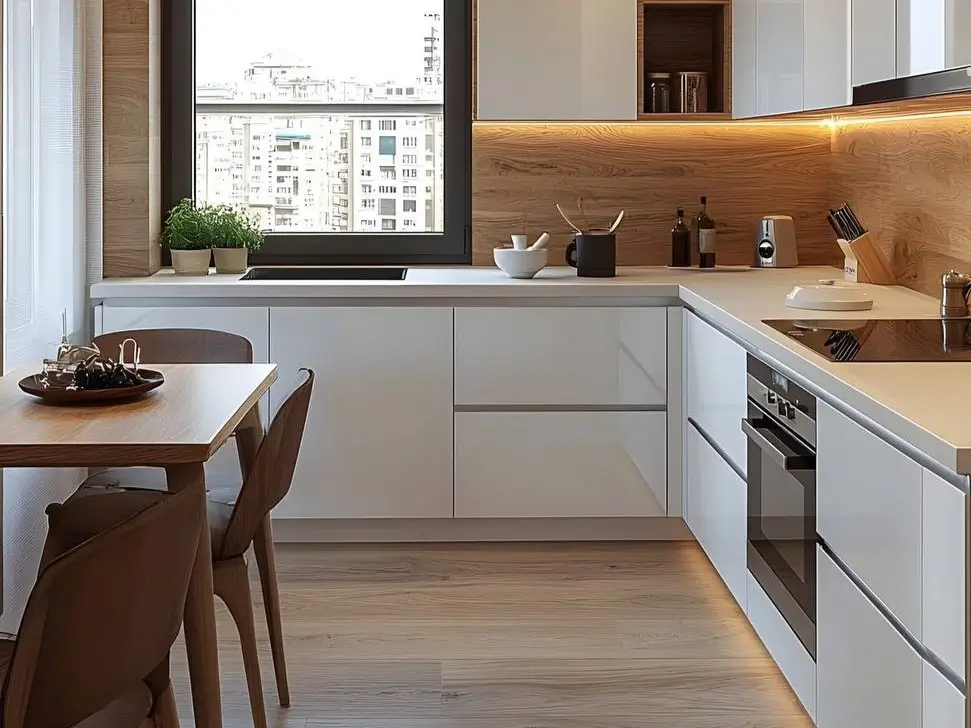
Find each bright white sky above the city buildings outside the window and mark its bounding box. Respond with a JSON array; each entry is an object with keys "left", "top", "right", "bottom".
[{"left": 196, "top": 0, "right": 445, "bottom": 84}]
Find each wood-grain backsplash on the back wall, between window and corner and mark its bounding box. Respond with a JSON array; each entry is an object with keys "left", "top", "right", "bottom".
[{"left": 472, "top": 123, "right": 841, "bottom": 265}]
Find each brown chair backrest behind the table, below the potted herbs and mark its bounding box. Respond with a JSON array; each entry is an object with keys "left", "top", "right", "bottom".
[{"left": 94, "top": 329, "right": 253, "bottom": 364}]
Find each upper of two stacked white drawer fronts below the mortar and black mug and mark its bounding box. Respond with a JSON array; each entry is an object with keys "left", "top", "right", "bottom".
[{"left": 455, "top": 308, "right": 667, "bottom": 405}]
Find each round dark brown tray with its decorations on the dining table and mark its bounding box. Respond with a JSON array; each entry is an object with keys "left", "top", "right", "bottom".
[{"left": 18, "top": 339, "right": 165, "bottom": 404}]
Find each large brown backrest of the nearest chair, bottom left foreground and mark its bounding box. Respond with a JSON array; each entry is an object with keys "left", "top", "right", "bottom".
[{"left": 3, "top": 490, "right": 205, "bottom": 728}]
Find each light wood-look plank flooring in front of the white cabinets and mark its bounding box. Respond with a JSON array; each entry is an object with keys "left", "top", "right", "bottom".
[{"left": 172, "top": 542, "right": 811, "bottom": 728}]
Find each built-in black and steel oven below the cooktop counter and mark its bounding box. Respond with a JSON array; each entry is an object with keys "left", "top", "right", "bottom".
[{"left": 742, "top": 355, "right": 816, "bottom": 659}]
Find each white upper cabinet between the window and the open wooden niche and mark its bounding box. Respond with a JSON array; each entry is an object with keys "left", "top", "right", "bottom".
[{"left": 476, "top": 0, "right": 637, "bottom": 121}]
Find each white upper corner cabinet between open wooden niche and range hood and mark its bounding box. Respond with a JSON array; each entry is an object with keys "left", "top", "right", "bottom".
[{"left": 732, "top": 0, "right": 851, "bottom": 118}]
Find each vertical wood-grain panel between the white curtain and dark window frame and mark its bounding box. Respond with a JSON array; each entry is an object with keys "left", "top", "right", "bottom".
[{"left": 102, "top": 0, "right": 161, "bottom": 277}]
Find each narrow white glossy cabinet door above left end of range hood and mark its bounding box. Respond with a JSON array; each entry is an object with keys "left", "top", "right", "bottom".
[{"left": 850, "top": 0, "right": 897, "bottom": 86}]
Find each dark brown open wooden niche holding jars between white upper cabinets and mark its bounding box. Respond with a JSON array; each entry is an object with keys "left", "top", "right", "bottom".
[{"left": 637, "top": 0, "right": 732, "bottom": 119}]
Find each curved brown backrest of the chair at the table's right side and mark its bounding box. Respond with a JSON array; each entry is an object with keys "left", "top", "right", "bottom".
[{"left": 217, "top": 369, "right": 314, "bottom": 559}]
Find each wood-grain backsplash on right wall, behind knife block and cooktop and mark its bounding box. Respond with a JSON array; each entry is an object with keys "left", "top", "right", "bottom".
[{"left": 832, "top": 110, "right": 971, "bottom": 296}]
